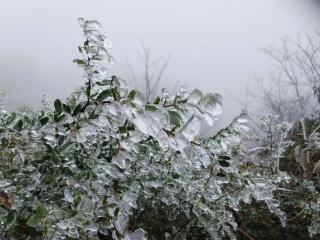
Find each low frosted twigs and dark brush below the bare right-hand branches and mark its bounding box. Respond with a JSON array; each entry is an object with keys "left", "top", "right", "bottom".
[{"left": 237, "top": 92, "right": 320, "bottom": 239}]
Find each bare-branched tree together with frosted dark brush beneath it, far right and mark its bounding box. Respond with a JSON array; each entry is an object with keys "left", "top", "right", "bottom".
[{"left": 231, "top": 33, "right": 320, "bottom": 240}]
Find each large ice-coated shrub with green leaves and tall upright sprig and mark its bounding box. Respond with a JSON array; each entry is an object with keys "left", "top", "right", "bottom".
[{"left": 0, "top": 19, "right": 288, "bottom": 240}]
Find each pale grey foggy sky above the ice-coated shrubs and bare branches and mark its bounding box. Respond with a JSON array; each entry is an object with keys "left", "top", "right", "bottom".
[{"left": 0, "top": 0, "right": 320, "bottom": 122}]
